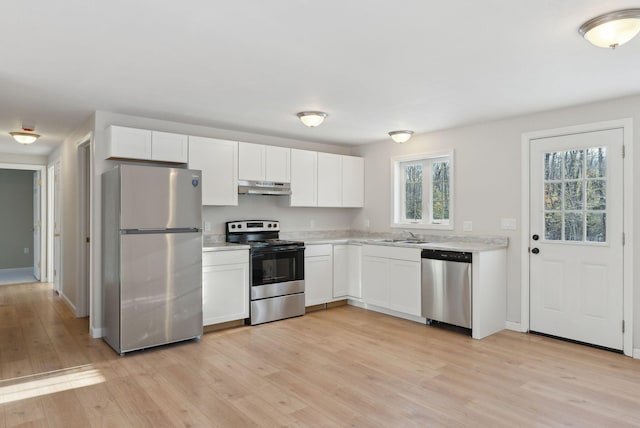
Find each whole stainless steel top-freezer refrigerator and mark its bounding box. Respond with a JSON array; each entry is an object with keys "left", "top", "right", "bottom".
[{"left": 102, "top": 165, "right": 202, "bottom": 354}]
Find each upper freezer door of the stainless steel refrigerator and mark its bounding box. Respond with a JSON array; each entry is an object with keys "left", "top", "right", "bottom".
[{"left": 120, "top": 165, "right": 202, "bottom": 229}]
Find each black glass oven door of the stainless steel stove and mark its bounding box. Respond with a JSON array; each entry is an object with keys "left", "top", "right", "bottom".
[{"left": 251, "top": 245, "right": 304, "bottom": 287}]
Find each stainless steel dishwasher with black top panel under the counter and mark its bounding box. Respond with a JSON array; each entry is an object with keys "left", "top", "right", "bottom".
[{"left": 422, "top": 249, "right": 471, "bottom": 328}]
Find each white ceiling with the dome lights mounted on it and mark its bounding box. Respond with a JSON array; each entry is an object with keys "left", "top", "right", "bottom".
[{"left": 0, "top": 0, "right": 640, "bottom": 155}]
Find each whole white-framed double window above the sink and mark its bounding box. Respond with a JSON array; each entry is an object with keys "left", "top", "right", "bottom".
[{"left": 391, "top": 152, "right": 453, "bottom": 229}]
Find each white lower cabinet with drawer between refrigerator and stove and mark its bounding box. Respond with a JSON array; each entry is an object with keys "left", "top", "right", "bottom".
[{"left": 202, "top": 250, "right": 249, "bottom": 326}]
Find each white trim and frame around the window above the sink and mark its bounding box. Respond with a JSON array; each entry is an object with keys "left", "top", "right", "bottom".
[{"left": 390, "top": 149, "right": 455, "bottom": 230}]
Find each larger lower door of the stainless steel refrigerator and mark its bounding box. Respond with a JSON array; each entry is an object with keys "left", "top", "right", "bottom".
[{"left": 120, "top": 232, "right": 202, "bottom": 353}]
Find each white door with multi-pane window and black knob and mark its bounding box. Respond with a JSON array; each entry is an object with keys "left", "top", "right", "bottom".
[{"left": 529, "top": 129, "right": 623, "bottom": 349}]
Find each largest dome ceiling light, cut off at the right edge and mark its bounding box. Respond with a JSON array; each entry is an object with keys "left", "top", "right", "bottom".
[{"left": 578, "top": 9, "right": 640, "bottom": 49}]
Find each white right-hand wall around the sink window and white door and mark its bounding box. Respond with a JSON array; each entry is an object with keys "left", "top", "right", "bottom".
[{"left": 354, "top": 96, "right": 640, "bottom": 343}]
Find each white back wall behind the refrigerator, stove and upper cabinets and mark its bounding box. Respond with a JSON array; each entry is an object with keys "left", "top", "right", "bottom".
[{"left": 90, "top": 111, "right": 354, "bottom": 337}]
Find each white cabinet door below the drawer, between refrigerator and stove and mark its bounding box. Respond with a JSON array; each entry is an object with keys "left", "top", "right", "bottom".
[{"left": 202, "top": 263, "right": 249, "bottom": 325}]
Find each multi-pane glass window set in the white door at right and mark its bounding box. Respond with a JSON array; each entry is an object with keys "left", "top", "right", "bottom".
[{"left": 544, "top": 147, "right": 607, "bottom": 242}]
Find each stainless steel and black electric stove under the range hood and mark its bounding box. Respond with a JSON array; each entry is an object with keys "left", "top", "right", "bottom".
[{"left": 226, "top": 220, "right": 305, "bottom": 325}]
